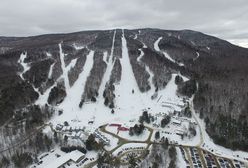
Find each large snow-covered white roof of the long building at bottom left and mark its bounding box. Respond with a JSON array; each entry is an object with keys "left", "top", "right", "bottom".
[{"left": 46, "top": 150, "right": 85, "bottom": 168}]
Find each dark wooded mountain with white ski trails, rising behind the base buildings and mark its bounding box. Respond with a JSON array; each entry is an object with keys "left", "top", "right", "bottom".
[{"left": 0, "top": 29, "right": 248, "bottom": 151}]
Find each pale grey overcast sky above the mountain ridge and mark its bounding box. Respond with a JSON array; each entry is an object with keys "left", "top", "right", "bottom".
[{"left": 0, "top": 0, "right": 248, "bottom": 46}]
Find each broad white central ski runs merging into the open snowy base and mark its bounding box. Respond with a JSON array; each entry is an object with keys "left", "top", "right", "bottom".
[{"left": 49, "top": 31, "right": 190, "bottom": 135}]
